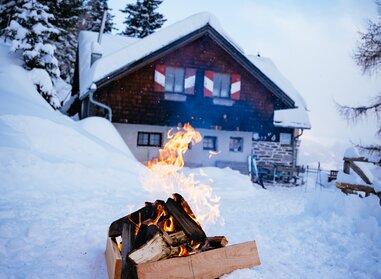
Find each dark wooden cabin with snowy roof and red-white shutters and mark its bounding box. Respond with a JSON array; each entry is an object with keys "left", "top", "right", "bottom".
[{"left": 73, "top": 13, "right": 311, "bottom": 173}]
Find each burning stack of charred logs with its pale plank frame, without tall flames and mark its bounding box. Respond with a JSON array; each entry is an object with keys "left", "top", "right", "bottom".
[{"left": 106, "top": 194, "right": 260, "bottom": 279}]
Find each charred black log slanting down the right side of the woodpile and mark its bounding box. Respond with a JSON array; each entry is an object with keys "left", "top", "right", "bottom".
[{"left": 165, "top": 198, "right": 206, "bottom": 243}]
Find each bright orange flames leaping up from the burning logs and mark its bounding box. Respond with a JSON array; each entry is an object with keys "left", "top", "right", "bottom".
[{"left": 142, "top": 123, "right": 223, "bottom": 230}]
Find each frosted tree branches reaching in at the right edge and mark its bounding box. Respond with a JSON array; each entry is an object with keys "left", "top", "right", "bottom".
[{"left": 339, "top": 1, "right": 381, "bottom": 156}]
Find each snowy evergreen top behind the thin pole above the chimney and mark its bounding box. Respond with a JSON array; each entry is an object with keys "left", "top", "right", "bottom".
[{"left": 83, "top": 0, "right": 115, "bottom": 33}]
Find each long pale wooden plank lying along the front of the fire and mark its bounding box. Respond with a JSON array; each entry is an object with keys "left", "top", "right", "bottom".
[{"left": 136, "top": 241, "right": 261, "bottom": 279}]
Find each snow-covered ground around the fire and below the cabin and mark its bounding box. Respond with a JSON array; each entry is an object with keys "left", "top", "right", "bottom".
[{"left": 0, "top": 42, "right": 381, "bottom": 278}]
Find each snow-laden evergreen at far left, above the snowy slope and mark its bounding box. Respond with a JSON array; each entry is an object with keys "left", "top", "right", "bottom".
[{"left": 4, "top": 0, "right": 60, "bottom": 109}]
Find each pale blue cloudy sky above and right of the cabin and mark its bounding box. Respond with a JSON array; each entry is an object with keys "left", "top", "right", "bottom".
[{"left": 109, "top": 0, "right": 381, "bottom": 166}]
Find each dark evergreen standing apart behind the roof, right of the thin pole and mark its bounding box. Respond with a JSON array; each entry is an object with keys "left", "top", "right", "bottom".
[{"left": 121, "top": 0, "right": 166, "bottom": 38}]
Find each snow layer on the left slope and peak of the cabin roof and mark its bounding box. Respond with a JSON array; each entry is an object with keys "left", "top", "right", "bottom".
[{"left": 79, "top": 12, "right": 243, "bottom": 96}]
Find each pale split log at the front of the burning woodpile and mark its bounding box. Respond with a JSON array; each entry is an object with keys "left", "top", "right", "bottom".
[{"left": 128, "top": 231, "right": 180, "bottom": 264}]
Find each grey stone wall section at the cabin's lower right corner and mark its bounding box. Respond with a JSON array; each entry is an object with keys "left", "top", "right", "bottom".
[{"left": 253, "top": 141, "right": 292, "bottom": 167}]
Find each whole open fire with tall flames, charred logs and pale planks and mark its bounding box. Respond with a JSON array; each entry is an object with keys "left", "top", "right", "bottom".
[{"left": 106, "top": 124, "right": 259, "bottom": 278}]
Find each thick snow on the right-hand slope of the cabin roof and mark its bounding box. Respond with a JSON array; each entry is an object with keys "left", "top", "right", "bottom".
[{"left": 247, "top": 55, "right": 311, "bottom": 129}]
